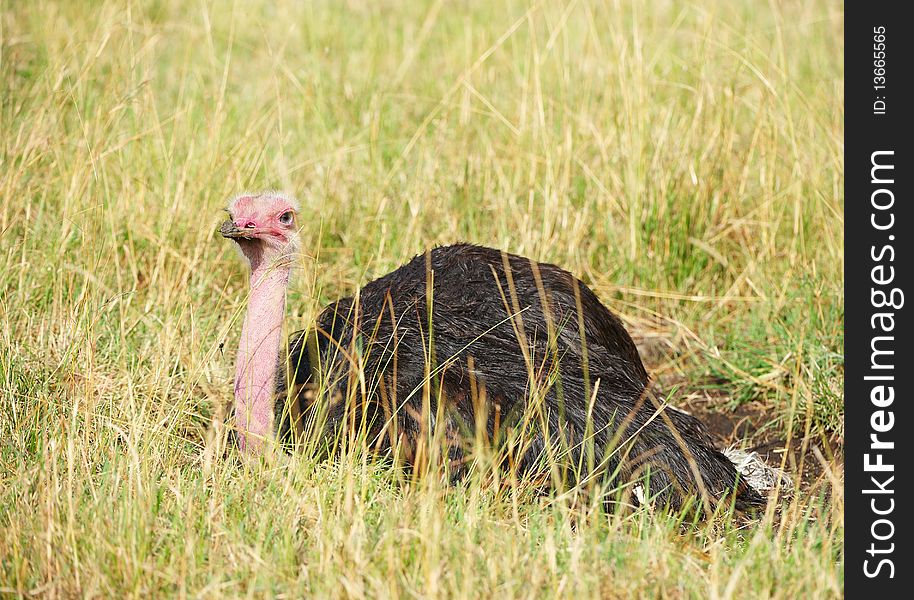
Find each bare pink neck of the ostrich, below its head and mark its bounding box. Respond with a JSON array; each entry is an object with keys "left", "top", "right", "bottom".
[{"left": 235, "top": 263, "right": 289, "bottom": 454}]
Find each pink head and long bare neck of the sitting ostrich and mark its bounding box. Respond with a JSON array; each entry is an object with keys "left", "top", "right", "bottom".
[{"left": 219, "top": 192, "right": 300, "bottom": 453}]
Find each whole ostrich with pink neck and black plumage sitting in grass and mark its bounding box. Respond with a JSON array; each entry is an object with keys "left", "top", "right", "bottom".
[{"left": 220, "top": 192, "right": 765, "bottom": 509}]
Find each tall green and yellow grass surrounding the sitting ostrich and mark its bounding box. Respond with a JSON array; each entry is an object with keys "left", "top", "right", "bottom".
[{"left": 0, "top": 0, "right": 844, "bottom": 598}]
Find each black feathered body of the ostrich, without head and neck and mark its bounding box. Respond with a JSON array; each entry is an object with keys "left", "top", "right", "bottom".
[{"left": 277, "top": 244, "right": 764, "bottom": 508}]
